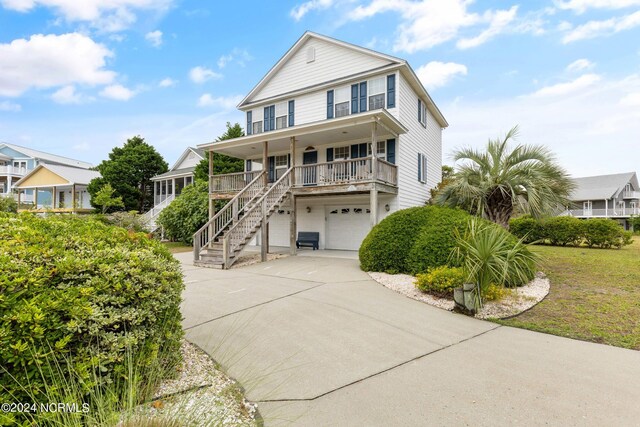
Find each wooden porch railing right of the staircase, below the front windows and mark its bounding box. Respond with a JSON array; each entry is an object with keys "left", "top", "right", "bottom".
[{"left": 294, "top": 157, "right": 398, "bottom": 186}]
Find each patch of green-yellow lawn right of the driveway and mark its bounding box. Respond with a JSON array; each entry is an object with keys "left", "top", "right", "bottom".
[{"left": 500, "top": 237, "right": 640, "bottom": 350}]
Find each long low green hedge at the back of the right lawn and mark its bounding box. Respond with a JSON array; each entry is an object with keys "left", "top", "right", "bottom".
[{"left": 509, "top": 216, "right": 632, "bottom": 248}]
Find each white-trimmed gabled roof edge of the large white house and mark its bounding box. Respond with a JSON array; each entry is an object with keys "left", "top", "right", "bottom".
[{"left": 237, "top": 31, "right": 449, "bottom": 128}]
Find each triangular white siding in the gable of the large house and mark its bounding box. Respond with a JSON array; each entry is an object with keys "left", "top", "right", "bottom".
[{"left": 249, "top": 38, "right": 391, "bottom": 101}]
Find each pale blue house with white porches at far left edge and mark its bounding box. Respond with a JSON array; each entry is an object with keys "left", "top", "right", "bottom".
[{"left": 0, "top": 142, "right": 91, "bottom": 203}]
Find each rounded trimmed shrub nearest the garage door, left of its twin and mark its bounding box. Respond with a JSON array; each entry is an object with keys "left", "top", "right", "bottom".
[{"left": 359, "top": 206, "right": 433, "bottom": 274}]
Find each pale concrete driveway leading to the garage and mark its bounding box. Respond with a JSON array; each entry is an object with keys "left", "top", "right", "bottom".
[{"left": 177, "top": 254, "right": 640, "bottom": 426}]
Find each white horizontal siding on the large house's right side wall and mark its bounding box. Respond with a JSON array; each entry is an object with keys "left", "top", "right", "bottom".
[{"left": 396, "top": 75, "right": 442, "bottom": 209}]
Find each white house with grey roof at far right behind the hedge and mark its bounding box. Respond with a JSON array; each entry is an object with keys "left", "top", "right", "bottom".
[{"left": 564, "top": 172, "right": 640, "bottom": 230}]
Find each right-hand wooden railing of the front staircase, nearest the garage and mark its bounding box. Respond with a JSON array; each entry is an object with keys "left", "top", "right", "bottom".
[{"left": 222, "top": 168, "right": 293, "bottom": 268}]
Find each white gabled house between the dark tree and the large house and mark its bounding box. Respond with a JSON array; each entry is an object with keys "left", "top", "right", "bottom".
[{"left": 145, "top": 147, "right": 205, "bottom": 231}]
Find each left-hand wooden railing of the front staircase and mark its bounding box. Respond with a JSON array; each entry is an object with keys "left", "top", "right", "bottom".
[{"left": 193, "top": 171, "right": 266, "bottom": 261}]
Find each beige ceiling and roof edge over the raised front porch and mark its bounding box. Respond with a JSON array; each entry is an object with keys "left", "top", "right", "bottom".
[{"left": 198, "top": 110, "right": 407, "bottom": 159}]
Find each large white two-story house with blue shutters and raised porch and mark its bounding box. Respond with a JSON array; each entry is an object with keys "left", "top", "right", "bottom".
[{"left": 194, "top": 32, "right": 448, "bottom": 267}]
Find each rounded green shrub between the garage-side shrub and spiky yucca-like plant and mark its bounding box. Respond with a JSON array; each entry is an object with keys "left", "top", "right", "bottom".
[{"left": 407, "top": 206, "right": 471, "bottom": 274}]
